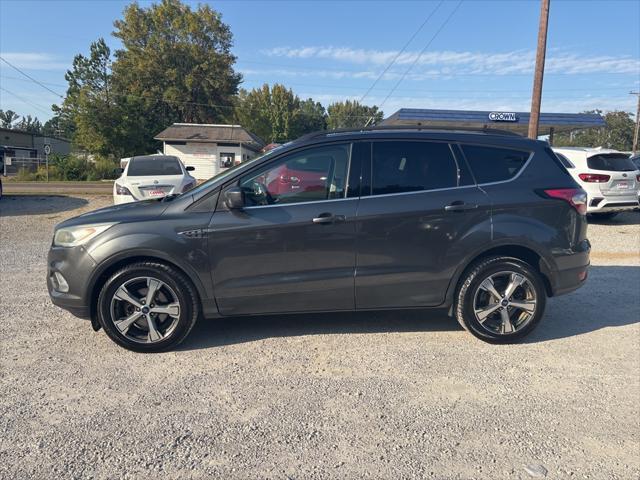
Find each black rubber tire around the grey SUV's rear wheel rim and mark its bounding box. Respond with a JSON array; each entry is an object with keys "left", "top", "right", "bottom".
[{"left": 454, "top": 257, "right": 547, "bottom": 343}]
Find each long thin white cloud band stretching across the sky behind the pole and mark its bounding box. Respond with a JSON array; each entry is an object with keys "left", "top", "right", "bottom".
[{"left": 263, "top": 46, "right": 640, "bottom": 75}]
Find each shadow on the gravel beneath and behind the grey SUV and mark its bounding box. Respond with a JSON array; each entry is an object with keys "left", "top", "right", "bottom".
[{"left": 178, "top": 266, "right": 640, "bottom": 350}]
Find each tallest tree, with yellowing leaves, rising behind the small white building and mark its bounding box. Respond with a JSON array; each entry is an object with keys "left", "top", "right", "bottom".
[{"left": 113, "top": 0, "right": 242, "bottom": 129}]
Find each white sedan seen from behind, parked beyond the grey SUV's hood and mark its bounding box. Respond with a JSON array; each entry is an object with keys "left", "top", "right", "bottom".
[{"left": 113, "top": 155, "right": 196, "bottom": 205}]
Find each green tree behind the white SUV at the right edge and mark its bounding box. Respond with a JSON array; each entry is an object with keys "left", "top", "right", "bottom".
[{"left": 553, "top": 110, "right": 635, "bottom": 150}]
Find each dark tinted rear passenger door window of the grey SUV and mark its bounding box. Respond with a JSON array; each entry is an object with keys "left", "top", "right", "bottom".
[{"left": 372, "top": 141, "right": 458, "bottom": 195}]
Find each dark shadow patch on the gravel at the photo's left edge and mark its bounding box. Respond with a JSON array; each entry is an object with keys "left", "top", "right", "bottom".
[{"left": 0, "top": 194, "right": 89, "bottom": 217}]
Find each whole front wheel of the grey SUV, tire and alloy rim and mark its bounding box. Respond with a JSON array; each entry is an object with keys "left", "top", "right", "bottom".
[{"left": 98, "top": 262, "right": 199, "bottom": 352}]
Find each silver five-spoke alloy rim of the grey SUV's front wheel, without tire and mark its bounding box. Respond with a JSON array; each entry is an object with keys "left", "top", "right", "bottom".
[{"left": 110, "top": 277, "right": 181, "bottom": 343}]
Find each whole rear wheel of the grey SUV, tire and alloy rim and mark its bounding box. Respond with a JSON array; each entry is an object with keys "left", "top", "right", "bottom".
[{"left": 455, "top": 257, "right": 547, "bottom": 343}]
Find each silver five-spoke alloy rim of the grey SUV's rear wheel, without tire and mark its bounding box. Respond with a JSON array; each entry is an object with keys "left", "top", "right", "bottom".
[{"left": 473, "top": 271, "right": 538, "bottom": 335}]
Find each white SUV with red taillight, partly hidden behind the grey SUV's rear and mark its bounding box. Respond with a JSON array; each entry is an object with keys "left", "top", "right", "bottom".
[{"left": 553, "top": 147, "right": 640, "bottom": 218}]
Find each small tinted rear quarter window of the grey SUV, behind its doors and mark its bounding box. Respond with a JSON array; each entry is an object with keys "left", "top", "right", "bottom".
[{"left": 461, "top": 145, "right": 531, "bottom": 183}]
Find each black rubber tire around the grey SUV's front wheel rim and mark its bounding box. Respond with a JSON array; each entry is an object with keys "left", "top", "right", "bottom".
[{"left": 97, "top": 261, "right": 200, "bottom": 353}]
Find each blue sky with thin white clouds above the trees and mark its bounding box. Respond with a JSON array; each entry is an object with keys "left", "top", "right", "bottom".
[{"left": 0, "top": 0, "right": 640, "bottom": 120}]
